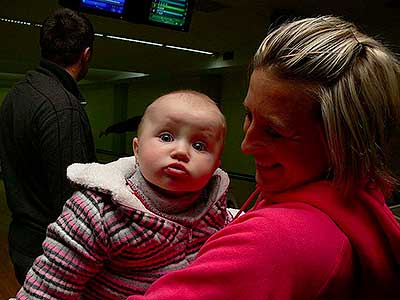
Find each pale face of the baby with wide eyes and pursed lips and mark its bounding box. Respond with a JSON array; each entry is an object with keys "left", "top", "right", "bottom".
[{"left": 133, "top": 95, "right": 224, "bottom": 194}]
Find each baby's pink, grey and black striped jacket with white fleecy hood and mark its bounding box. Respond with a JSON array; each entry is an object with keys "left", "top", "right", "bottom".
[{"left": 17, "top": 157, "right": 232, "bottom": 300}]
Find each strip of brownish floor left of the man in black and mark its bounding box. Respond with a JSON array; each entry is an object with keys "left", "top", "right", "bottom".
[{"left": 0, "top": 180, "right": 20, "bottom": 300}]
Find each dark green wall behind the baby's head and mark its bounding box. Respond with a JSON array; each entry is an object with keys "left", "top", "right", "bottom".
[{"left": 81, "top": 69, "right": 254, "bottom": 205}]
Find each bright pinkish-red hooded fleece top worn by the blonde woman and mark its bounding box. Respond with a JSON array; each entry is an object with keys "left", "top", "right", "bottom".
[{"left": 128, "top": 181, "right": 400, "bottom": 300}]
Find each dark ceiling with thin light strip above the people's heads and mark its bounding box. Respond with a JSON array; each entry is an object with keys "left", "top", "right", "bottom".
[{"left": 0, "top": 0, "right": 400, "bottom": 81}]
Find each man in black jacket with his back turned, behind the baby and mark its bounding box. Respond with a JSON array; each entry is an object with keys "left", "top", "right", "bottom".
[{"left": 0, "top": 9, "right": 96, "bottom": 284}]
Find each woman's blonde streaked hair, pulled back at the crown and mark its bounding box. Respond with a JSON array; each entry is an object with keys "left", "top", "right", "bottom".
[{"left": 250, "top": 16, "right": 400, "bottom": 193}]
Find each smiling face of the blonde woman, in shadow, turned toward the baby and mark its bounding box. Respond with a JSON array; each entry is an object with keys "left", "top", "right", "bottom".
[{"left": 242, "top": 69, "right": 328, "bottom": 192}]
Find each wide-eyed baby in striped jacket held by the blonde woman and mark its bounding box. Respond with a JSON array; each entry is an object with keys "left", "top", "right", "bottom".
[{"left": 17, "top": 90, "right": 232, "bottom": 299}]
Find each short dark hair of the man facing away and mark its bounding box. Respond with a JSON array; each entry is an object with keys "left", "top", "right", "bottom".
[{"left": 40, "top": 8, "right": 94, "bottom": 67}]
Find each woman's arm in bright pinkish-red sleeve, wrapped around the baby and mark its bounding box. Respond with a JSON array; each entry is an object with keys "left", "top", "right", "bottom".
[{"left": 128, "top": 204, "right": 352, "bottom": 300}]
